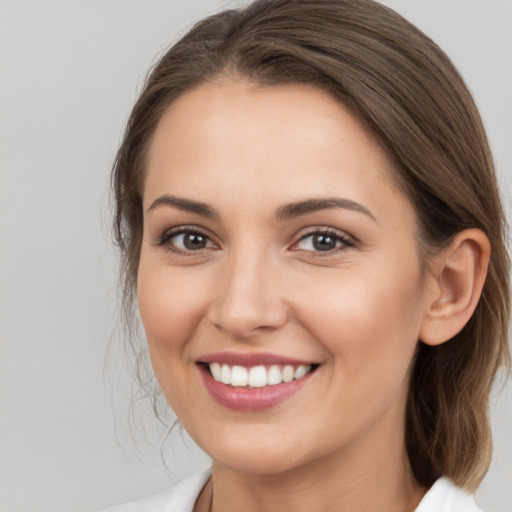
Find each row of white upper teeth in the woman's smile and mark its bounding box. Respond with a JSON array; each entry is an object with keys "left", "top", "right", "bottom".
[{"left": 209, "top": 363, "right": 311, "bottom": 388}]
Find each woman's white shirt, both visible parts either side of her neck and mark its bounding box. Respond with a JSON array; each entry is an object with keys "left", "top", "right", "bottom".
[{"left": 104, "top": 469, "right": 482, "bottom": 512}]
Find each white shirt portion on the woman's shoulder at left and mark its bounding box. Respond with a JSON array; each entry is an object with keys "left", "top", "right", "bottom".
[{"left": 99, "top": 469, "right": 211, "bottom": 512}]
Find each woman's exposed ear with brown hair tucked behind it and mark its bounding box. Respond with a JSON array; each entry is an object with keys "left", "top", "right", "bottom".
[{"left": 419, "top": 229, "right": 491, "bottom": 345}]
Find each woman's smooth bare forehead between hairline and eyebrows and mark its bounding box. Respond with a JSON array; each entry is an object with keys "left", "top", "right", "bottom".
[{"left": 144, "top": 80, "right": 412, "bottom": 222}]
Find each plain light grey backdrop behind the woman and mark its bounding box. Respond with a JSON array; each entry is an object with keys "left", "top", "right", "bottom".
[{"left": 0, "top": 0, "right": 512, "bottom": 512}]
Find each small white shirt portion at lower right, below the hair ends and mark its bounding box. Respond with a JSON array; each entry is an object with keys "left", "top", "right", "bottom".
[{"left": 416, "top": 478, "right": 482, "bottom": 512}]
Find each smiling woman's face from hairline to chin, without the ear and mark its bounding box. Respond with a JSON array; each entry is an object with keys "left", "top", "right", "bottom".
[{"left": 138, "top": 80, "right": 432, "bottom": 474}]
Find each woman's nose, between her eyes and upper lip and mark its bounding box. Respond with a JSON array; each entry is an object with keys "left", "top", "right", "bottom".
[{"left": 209, "top": 251, "right": 288, "bottom": 339}]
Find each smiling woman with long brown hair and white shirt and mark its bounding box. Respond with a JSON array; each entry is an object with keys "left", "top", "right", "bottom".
[{"left": 103, "top": 0, "right": 509, "bottom": 512}]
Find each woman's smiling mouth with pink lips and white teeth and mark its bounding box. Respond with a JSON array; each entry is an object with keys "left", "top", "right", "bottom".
[{"left": 197, "top": 353, "right": 320, "bottom": 411}]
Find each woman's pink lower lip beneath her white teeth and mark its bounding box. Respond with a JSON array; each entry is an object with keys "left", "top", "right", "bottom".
[{"left": 199, "top": 367, "right": 312, "bottom": 411}]
